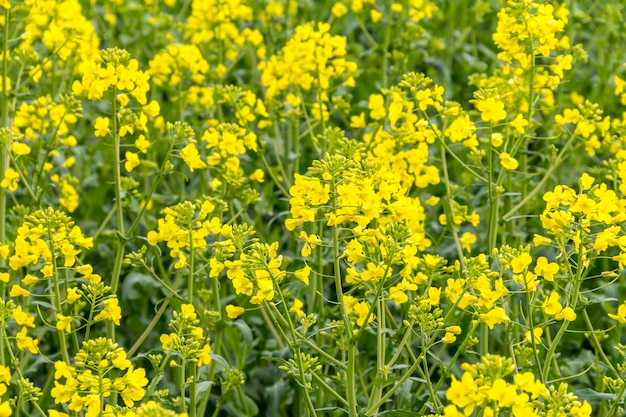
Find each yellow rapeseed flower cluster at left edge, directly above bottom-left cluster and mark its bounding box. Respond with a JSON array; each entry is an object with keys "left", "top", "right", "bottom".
[{"left": 0, "top": 209, "right": 122, "bottom": 338}]
